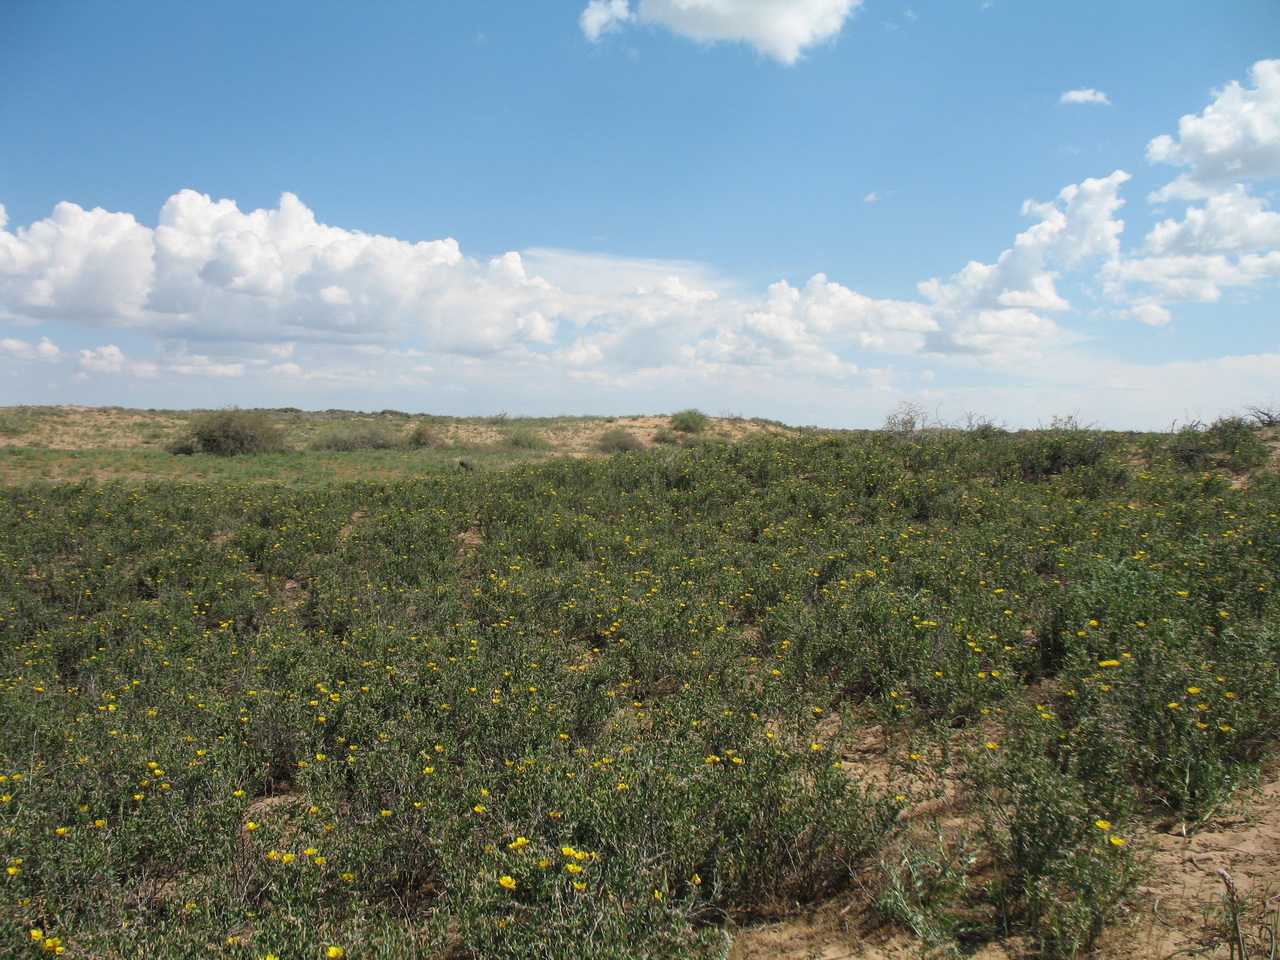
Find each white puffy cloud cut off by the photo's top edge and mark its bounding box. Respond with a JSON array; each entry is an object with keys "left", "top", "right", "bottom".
[{"left": 579, "top": 0, "right": 863, "bottom": 64}]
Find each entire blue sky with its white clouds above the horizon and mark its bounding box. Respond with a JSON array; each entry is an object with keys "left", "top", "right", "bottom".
[{"left": 0, "top": 0, "right": 1280, "bottom": 428}]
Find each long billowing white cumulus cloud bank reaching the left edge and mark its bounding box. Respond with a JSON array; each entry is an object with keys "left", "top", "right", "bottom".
[{"left": 0, "top": 189, "right": 562, "bottom": 353}]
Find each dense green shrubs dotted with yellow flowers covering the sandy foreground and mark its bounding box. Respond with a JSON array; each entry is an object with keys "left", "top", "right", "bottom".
[{"left": 0, "top": 424, "right": 1280, "bottom": 960}]
